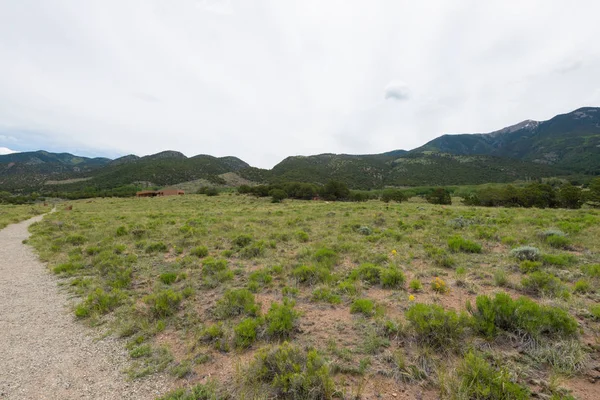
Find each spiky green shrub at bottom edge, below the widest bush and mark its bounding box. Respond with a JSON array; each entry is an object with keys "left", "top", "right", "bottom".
[{"left": 452, "top": 351, "right": 530, "bottom": 400}]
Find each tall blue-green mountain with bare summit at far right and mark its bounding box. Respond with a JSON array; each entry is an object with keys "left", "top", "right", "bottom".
[{"left": 411, "top": 107, "right": 600, "bottom": 174}]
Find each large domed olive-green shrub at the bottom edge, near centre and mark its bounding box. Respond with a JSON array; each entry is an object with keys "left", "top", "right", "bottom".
[{"left": 240, "top": 342, "right": 334, "bottom": 400}]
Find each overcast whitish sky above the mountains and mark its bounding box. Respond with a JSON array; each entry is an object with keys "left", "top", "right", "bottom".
[{"left": 0, "top": 0, "right": 600, "bottom": 167}]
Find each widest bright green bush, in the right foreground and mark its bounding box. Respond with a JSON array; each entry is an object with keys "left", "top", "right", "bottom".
[{"left": 468, "top": 293, "right": 578, "bottom": 338}]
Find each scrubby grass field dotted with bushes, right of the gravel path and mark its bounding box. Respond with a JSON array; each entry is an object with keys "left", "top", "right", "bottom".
[{"left": 25, "top": 194, "right": 600, "bottom": 399}]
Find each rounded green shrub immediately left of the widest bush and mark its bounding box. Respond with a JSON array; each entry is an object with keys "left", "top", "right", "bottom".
[{"left": 406, "top": 303, "right": 467, "bottom": 349}]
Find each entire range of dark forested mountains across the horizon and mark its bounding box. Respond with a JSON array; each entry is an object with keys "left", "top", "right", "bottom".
[{"left": 0, "top": 107, "right": 600, "bottom": 192}]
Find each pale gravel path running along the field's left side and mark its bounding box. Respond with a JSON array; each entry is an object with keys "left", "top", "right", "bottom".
[{"left": 0, "top": 216, "right": 173, "bottom": 400}]
